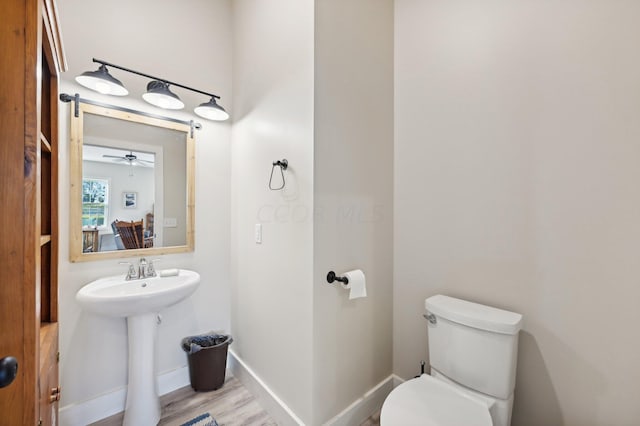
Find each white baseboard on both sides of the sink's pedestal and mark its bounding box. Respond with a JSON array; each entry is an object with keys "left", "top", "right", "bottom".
[{"left": 59, "top": 366, "right": 190, "bottom": 426}]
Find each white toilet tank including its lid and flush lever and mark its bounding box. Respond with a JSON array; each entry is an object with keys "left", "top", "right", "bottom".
[{"left": 425, "top": 295, "right": 522, "bottom": 399}]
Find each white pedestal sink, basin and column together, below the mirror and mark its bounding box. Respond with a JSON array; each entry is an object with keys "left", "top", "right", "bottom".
[{"left": 76, "top": 269, "right": 200, "bottom": 426}]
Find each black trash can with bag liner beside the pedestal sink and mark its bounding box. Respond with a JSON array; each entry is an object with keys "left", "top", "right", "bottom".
[{"left": 182, "top": 333, "right": 233, "bottom": 392}]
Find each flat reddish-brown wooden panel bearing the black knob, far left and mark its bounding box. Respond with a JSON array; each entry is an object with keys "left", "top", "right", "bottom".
[{"left": 0, "top": 1, "right": 33, "bottom": 425}]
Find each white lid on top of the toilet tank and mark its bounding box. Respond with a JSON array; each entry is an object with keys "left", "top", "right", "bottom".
[{"left": 424, "top": 294, "right": 522, "bottom": 334}]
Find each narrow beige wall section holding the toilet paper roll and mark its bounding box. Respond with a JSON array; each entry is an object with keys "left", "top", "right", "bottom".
[{"left": 312, "top": 0, "right": 393, "bottom": 425}]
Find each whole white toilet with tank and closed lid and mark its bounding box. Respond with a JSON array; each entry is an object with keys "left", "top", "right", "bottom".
[{"left": 380, "top": 295, "right": 522, "bottom": 426}]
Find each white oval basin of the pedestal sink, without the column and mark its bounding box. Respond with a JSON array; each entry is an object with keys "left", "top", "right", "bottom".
[{"left": 76, "top": 269, "right": 200, "bottom": 317}]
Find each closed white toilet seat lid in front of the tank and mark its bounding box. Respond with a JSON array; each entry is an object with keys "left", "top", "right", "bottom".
[{"left": 380, "top": 374, "right": 493, "bottom": 426}]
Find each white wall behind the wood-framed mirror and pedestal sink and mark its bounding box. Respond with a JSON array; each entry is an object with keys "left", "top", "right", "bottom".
[{"left": 58, "top": 0, "right": 231, "bottom": 414}]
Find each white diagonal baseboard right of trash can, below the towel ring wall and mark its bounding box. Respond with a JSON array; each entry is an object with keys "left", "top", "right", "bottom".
[{"left": 227, "top": 349, "right": 304, "bottom": 426}]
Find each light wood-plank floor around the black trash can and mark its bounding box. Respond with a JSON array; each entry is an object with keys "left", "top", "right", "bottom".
[{"left": 92, "top": 373, "right": 380, "bottom": 426}]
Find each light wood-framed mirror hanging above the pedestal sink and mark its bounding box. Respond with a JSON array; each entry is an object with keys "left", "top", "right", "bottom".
[{"left": 69, "top": 100, "right": 195, "bottom": 262}]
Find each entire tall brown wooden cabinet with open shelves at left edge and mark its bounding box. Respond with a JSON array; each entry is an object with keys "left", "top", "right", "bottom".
[{"left": 0, "top": 0, "right": 64, "bottom": 426}]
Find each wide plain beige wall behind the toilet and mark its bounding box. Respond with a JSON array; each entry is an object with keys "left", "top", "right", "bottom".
[{"left": 394, "top": 0, "right": 640, "bottom": 426}]
